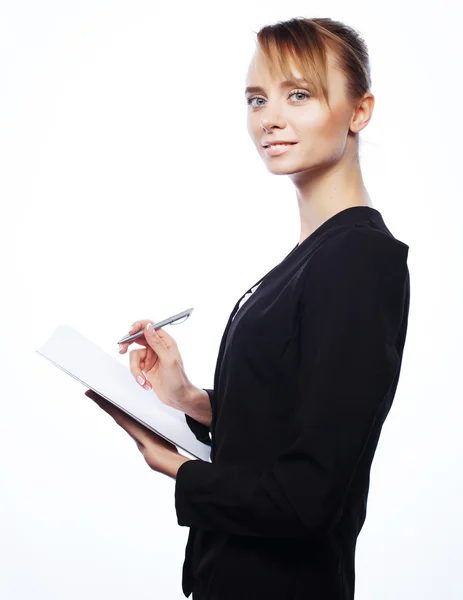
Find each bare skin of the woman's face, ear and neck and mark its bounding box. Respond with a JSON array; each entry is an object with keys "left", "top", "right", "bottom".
[{"left": 245, "top": 45, "right": 374, "bottom": 243}]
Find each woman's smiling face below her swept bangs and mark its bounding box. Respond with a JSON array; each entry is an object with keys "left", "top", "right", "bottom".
[{"left": 245, "top": 50, "right": 366, "bottom": 175}]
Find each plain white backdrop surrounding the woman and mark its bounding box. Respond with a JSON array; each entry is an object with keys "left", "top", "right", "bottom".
[{"left": 0, "top": 0, "right": 463, "bottom": 600}]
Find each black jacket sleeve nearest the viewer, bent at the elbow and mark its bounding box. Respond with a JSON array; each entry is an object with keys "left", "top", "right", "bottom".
[{"left": 175, "top": 227, "right": 408, "bottom": 537}]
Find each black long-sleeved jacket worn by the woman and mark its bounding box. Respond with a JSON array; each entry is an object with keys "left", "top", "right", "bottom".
[{"left": 175, "top": 206, "right": 410, "bottom": 600}]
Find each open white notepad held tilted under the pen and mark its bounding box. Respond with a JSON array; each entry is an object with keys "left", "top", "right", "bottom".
[{"left": 36, "top": 325, "right": 211, "bottom": 462}]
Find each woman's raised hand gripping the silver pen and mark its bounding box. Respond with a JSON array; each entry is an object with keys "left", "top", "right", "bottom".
[{"left": 119, "top": 319, "right": 194, "bottom": 410}]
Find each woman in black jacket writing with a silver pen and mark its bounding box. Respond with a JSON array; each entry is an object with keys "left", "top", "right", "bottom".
[{"left": 88, "top": 18, "right": 410, "bottom": 600}]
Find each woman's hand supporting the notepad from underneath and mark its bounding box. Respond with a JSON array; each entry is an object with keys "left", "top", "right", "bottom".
[{"left": 85, "top": 389, "right": 191, "bottom": 479}]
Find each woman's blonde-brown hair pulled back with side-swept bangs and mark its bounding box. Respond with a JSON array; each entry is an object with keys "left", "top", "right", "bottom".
[{"left": 254, "top": 17, "right": 371, "bottom": 110}]
